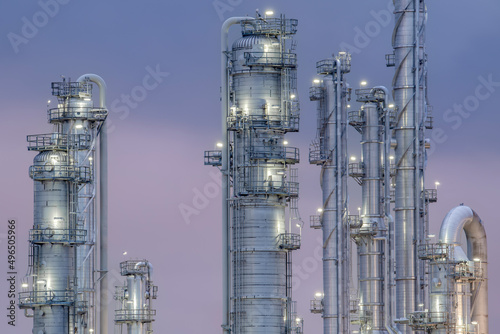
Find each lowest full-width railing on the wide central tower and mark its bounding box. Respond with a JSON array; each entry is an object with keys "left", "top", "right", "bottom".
[{"left": 238, "top": 181, "right": 299, "bottom": 197}]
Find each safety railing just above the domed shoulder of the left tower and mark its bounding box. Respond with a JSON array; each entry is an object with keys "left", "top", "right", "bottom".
[{"left": 27, "top": 133, "right": 92, "bottom": 151}]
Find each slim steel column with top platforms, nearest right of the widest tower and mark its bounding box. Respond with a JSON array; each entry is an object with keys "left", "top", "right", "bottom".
[{"left": 309, "top": 52, "right": 351, "bottom": 334}]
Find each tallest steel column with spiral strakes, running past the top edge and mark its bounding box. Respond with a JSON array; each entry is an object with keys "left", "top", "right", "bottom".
[{"left": 392, "top": 0, "right": 427, "bottom": 334}]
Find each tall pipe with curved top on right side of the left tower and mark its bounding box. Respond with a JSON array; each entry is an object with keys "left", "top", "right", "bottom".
[{"left": 77, "top": 74, "right": 108, "bottom": 334}]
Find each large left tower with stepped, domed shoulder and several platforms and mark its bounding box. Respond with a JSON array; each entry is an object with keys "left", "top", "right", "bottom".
[{"left": 19, "top": 81, "right": 107, "bottom": 334}]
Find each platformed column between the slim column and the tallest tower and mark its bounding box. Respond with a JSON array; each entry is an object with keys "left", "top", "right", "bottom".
[{"left": 349, "top": 88, "right": 390, "bottom": 333}]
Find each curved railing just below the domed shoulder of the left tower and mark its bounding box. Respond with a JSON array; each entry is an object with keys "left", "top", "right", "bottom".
[{"left": 29, "top": 163, "right": 92, "bottom": 183}]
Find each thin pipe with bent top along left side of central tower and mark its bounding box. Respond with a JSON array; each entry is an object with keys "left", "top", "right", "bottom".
[{"left": 221, "top": 17, "right": 253, "bottom": 334}]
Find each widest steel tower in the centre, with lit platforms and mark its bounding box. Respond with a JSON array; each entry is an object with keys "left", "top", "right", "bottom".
[{"left": 205, "top": 13, "right": 302, "bottom": 334}]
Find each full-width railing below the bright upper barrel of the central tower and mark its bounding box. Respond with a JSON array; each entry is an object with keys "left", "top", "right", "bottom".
[{"left": 227, "top": 115, "right": 299, "bottom": 132}]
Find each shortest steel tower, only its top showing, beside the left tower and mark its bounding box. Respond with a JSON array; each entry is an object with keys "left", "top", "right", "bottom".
[{"left": 115, "top": 260, "right": 158, "bottom": 334}]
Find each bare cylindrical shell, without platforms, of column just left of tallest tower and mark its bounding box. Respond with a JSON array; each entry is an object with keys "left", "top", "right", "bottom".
[{"left": 354, "top": 102, "right": 387, "bottom": 333}]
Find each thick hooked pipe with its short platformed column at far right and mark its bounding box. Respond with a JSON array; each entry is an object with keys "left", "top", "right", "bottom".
[{"left": 410, "top": 205, "right": 489, "bottom": 334}]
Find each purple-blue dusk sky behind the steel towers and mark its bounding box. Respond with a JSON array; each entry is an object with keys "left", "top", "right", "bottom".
[{"left": 0, "top": 0, "right": 500, "bottom": 334}]
